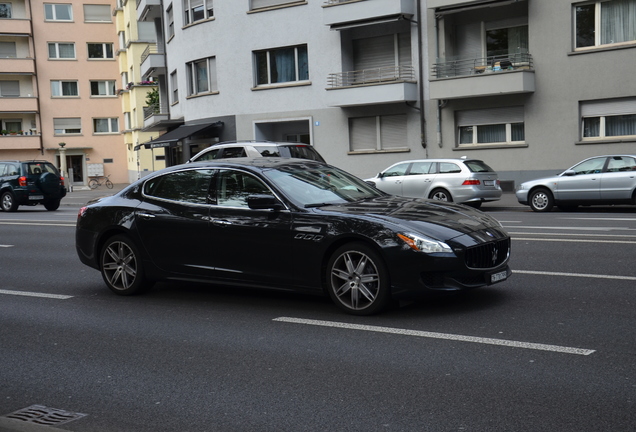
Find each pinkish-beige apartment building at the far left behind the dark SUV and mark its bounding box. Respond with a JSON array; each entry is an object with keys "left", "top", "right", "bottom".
[{"left": 0, "top": 0, "right": 128, "bottom": 186}]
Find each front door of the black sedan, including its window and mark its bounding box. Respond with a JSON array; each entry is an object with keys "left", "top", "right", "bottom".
[{"left": 209, "top": 169, "right": 294, "bottom": 286}]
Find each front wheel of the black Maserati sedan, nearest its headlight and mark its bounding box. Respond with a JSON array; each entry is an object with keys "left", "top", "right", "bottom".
[{"left": 327, "top": 243, "right": 390, "bottom": 315}]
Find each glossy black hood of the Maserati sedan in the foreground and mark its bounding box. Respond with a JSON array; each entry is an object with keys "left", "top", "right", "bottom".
[{"left": 319, "top": 196, "right": 507, "bottom": 242}]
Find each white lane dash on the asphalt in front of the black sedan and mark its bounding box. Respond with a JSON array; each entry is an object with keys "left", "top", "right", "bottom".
[{"left": 274, "top": 317, "right": 596, "bottom": 355}]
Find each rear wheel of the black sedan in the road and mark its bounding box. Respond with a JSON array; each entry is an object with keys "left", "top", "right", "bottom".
[{"left": 100, "top": 235, "right": 152, "bottom": 295}]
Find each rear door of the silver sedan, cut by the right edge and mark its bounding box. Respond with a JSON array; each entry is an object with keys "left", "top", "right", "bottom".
[{"left": 601, "top": 156, "right": 636, "bottom": 201}]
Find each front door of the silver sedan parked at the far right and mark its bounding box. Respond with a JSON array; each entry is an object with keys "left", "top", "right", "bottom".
[{"left": 554, "top": 157, "right": 607, "bottom": 201}]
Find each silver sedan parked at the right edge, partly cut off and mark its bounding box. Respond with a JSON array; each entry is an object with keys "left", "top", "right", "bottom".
[{"left": 516, "top": 155, "right": 636, "bottom": 212}]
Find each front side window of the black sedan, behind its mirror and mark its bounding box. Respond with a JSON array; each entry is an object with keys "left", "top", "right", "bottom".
[{"left": 216, "top": 170, "right": 272, "bottom": 208}]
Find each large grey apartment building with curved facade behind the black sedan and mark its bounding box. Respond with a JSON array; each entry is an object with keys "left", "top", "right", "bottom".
[{"left": 137, "top": 0, "right": 636, "bottom": 187}]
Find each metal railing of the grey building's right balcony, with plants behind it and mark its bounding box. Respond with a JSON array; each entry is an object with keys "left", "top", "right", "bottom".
[{"left": 431, "top": 53, "right": 534, "bottom": 78}]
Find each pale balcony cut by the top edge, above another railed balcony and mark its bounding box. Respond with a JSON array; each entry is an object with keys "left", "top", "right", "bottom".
[{"left": 322, "top": 0, "right": 416, "bottom": 30}]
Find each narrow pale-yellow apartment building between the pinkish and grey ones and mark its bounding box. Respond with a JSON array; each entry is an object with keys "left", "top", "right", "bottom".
[{"left": 113, "top": 0, "right": 166, "bottom": 182}]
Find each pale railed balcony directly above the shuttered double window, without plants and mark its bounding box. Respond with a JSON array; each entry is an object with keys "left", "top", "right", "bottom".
[{"left": 327, "top": 66, "right": 417, "bottom": 107}]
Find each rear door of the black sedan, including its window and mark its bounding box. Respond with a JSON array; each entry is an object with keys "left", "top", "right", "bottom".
[{"left": 135, "top": 169, "right": 214, "bottom": 277}]
